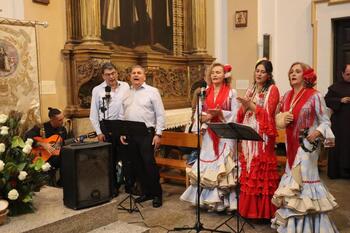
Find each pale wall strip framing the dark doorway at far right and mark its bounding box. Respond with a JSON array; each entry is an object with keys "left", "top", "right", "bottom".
[{"left": 316, "top": 2, "right": 350, "bottom": 94}]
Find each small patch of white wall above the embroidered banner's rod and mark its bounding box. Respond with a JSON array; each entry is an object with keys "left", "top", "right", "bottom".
[{"left": 0, "top": 0, "right": 24, "bottom": 19}]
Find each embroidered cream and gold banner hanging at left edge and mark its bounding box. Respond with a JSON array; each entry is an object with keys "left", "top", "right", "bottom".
[{"left": 0, "top": 18, "right": 40, "bottom": 119}]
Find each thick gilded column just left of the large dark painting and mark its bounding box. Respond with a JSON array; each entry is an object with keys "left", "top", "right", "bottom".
[{"left": 80, "top": 0, "right": 101, "bottom": 44}]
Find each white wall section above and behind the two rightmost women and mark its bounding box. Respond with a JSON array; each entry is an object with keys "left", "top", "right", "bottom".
[{"left": 257, "top": 0, "right": 312, "bottom": 95}]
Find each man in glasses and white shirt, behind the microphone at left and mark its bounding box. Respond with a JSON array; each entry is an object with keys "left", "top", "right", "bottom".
[{"left": 90, "top": 62, "right": 129, "bottom": 195}]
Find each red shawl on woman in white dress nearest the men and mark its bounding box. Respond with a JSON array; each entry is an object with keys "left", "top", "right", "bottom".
[{"left": 205, "top": 84, "right": 230, "bottom": 157}]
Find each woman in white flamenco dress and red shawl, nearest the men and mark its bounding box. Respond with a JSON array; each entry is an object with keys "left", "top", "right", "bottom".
[{"left": 180, "top": 63, "right": 238, "bottom": 211}]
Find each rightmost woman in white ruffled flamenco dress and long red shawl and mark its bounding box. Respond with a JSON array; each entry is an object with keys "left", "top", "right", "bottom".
[{"left": 271, "top": 62, "right": 338, "bottom": 233}]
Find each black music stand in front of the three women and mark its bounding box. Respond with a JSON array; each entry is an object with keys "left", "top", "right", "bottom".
[{"left": 208, "top": 123, "right": 263, "bottom": 233}]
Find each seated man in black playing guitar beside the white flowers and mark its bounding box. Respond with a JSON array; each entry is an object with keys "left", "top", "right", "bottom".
[{"left": 25, "top": 107, "right": 67, "bottom": 169}]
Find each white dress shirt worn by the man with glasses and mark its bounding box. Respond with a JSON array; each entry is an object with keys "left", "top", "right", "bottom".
[{"left": 90, "top": 81, "right": 130, "bottom": 134}]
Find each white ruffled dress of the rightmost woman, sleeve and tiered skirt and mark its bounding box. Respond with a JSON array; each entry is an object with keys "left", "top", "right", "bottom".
[{"left": 271, "top": 93, "right": 338, "bottom": 233}]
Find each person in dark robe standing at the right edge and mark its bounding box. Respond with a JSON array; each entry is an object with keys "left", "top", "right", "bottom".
[{"left": 325, "top": 64, "right": 350, "bottom": 179}]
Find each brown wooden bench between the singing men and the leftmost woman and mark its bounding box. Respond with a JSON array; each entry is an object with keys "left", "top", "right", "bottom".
[{"left": 155, "top": 131, "right": 201, "bottom": 187}]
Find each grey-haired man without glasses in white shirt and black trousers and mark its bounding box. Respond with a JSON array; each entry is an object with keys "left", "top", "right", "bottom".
[{"left": 121, "top": 65, "right": 165, "bottom": 208}]
